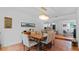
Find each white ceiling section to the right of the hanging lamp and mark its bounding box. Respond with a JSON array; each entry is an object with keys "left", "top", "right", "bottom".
[{"left": 48, "top": 7, "right": 77, "bottom": 16}]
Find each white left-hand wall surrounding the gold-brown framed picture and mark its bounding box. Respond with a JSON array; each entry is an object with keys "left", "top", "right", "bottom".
[{"left": 0, "top": 10, "right": 24, "bottom": 46}]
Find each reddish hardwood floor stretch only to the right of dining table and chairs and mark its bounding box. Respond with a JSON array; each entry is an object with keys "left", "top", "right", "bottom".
[{"left": 49, "top": 39, "right": 79, "bottom": 51}]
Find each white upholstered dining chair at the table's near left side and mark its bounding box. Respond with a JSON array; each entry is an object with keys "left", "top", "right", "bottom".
[{"left": 21, "top": 34, "right": 37, "bottom": 50}]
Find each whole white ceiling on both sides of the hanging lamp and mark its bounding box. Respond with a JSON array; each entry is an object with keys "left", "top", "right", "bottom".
[{"left": 0, "top": 7, "right": 77, "bottom": 17}]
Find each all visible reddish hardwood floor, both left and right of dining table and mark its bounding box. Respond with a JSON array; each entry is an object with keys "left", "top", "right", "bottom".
[{"left": 1, "top": 39, "right": 79, "bottom": 51}]
